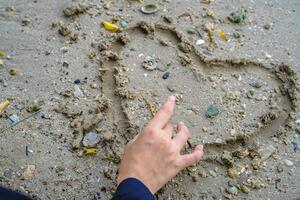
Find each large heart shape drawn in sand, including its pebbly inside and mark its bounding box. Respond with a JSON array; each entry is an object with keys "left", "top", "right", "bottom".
[{"left": 100, "top": 22, "right": 298, "bottom": 164}]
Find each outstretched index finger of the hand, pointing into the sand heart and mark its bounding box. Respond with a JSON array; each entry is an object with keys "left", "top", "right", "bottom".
[{"left": 149, "top": 95, "right": 175, "bottom": 128}]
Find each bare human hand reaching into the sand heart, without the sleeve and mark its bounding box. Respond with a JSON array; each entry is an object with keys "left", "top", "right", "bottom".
[{"left": 118, "top": 96, "right": 203, "bottom": 194}]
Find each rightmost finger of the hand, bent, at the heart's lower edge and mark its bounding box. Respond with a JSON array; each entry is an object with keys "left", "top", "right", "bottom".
[{"left": 179, "top": 144, "right": 203, "bottom": 169}]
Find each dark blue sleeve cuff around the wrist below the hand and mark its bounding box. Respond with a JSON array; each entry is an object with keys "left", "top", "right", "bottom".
[{"left": 112, "top": 178, "right": 155, "bottom": 200}]
